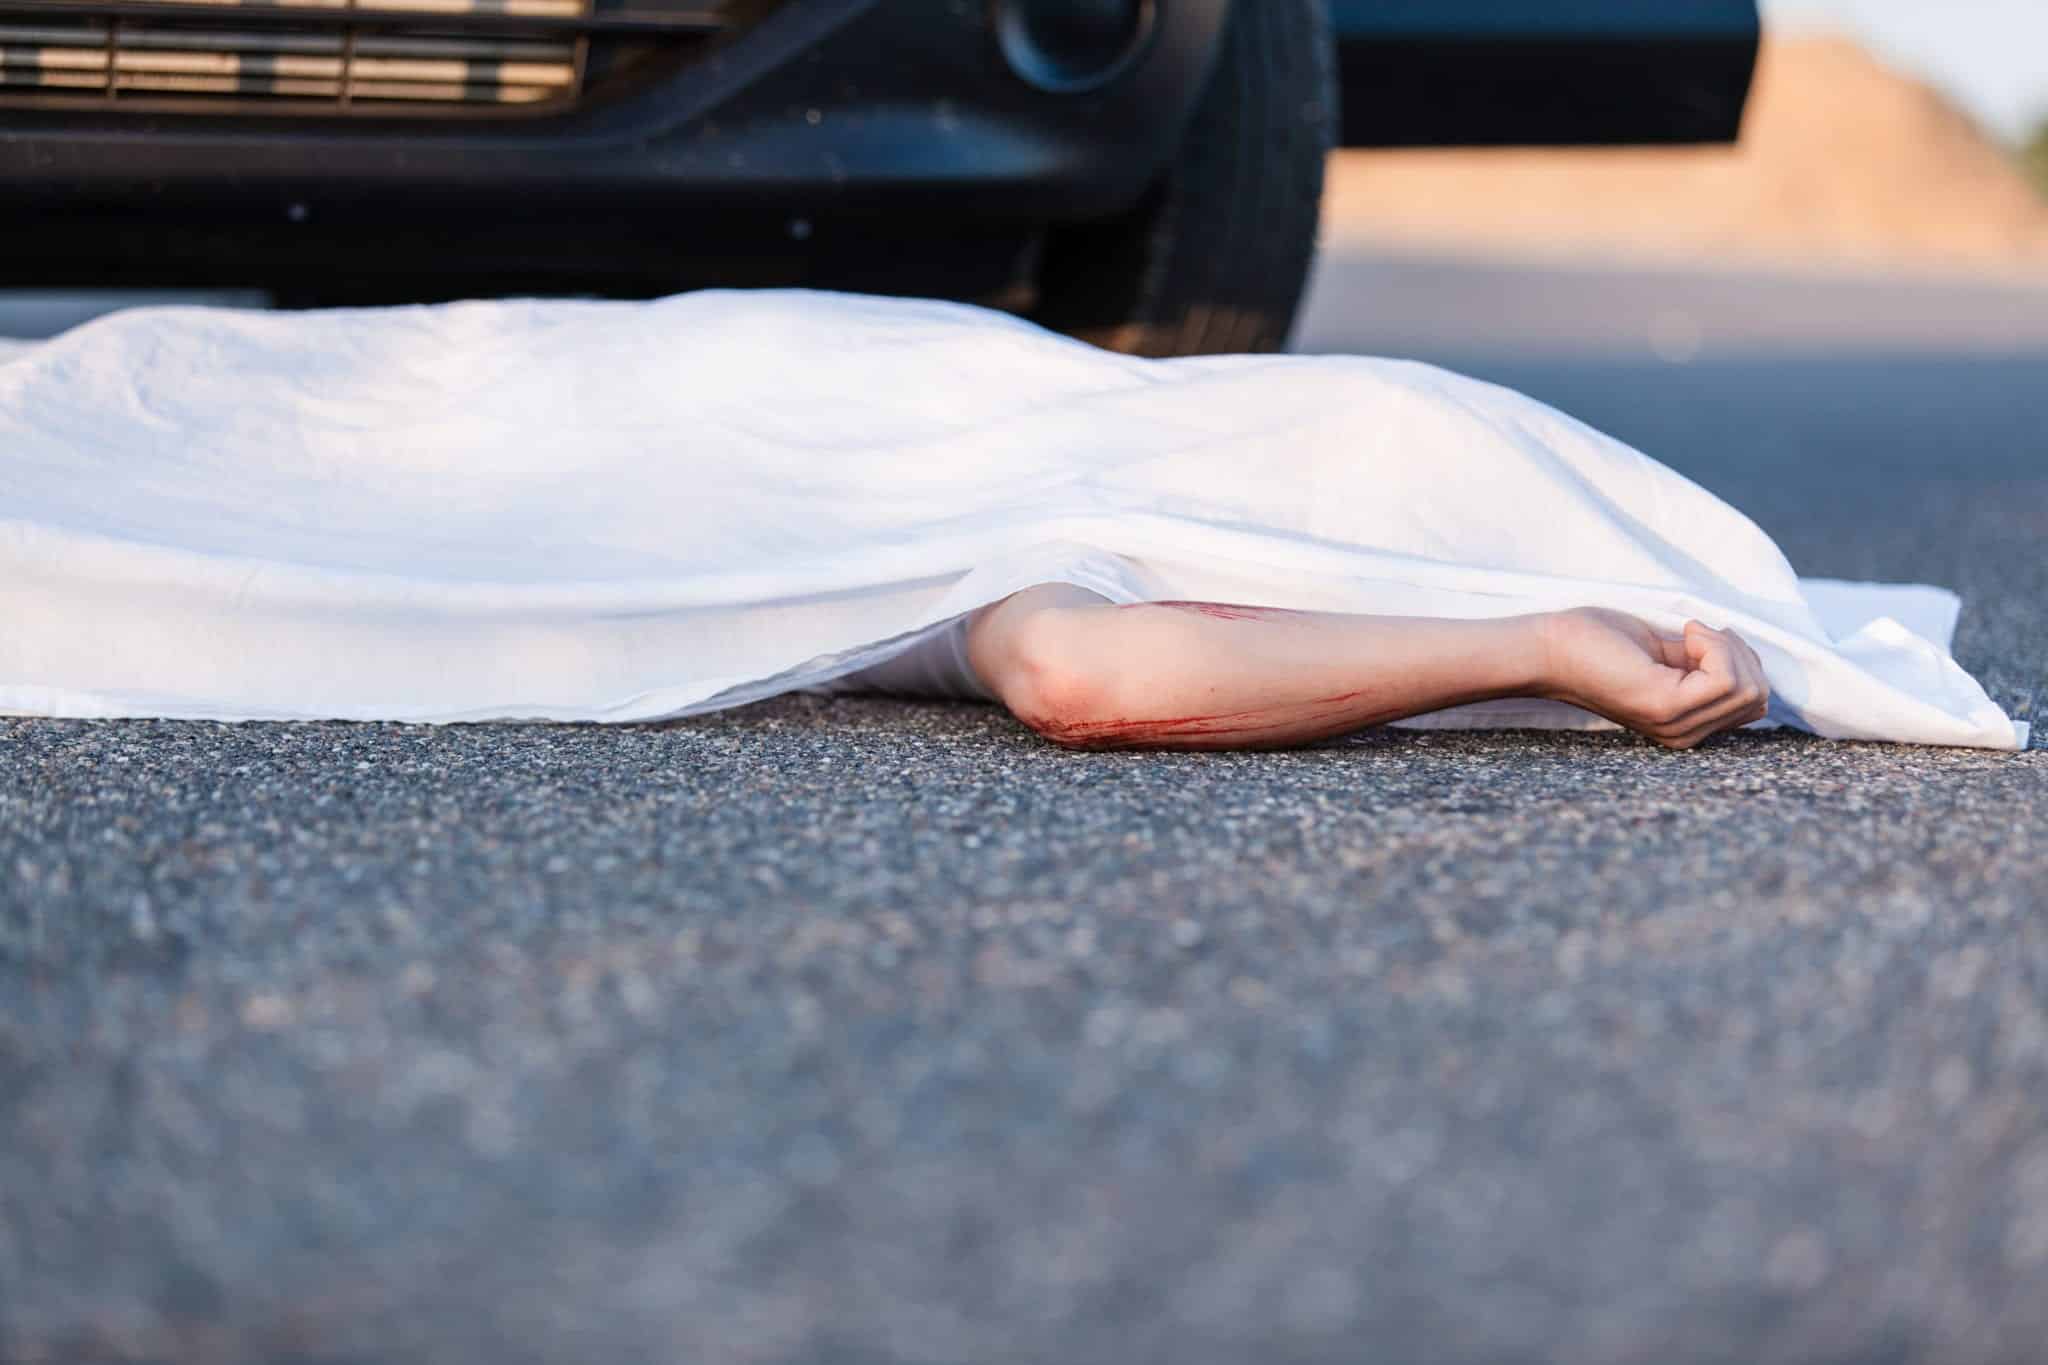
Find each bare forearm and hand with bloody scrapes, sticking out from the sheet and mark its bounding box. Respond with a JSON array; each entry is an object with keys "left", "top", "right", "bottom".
[{"left": 967, "top": 583, "right": 1769, "bottom": 749}]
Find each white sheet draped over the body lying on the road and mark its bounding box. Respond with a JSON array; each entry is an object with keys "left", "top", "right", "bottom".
[{"left": 0, "top": 293, "right": 2023, "bottom": 749}]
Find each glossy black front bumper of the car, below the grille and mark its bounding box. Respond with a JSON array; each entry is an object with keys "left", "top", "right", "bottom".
[{"left": 0, "top": 0, "right": 1227, "bottom": 215}]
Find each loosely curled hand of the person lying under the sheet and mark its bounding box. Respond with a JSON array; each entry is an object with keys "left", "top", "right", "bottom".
[{"left": 1544, "top": 608, "right": 1772, "bottom": 749}]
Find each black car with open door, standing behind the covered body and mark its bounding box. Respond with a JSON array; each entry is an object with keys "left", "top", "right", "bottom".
[{"left": 0, "top": 0, "right": 1757, "bottom": 354}]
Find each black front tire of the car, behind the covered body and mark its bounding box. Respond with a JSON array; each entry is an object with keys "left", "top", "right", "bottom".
[{"left": 1034, "top": 0, "right": 1337, "bottom": 356}]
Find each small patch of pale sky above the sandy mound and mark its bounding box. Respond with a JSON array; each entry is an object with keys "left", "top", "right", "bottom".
[{"left": 1763, "top": 0, "right": 2048, "bottom": 137}]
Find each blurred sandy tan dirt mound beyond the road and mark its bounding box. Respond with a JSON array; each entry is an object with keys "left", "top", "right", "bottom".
[{"left": 1325, "top": 37, "right": 2048, "bottom": 274}]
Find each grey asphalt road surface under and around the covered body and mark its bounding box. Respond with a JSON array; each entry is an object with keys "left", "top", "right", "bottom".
[{"left": 0, "top": 262, "right": 2048, "bottom": 1365}]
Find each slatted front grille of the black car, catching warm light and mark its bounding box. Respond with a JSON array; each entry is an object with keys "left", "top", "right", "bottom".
[{"left": 0, "top": 0, "right": 762, "bottom": 115}]
